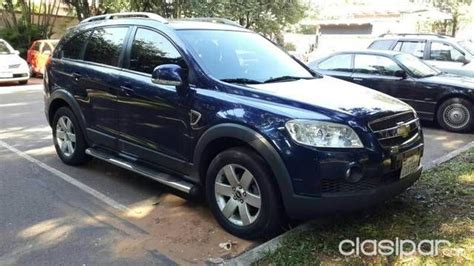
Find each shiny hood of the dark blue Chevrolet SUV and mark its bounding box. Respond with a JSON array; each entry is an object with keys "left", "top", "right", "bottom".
[{"left": 248, "top": 76, "right": 412, "bottom": 118}]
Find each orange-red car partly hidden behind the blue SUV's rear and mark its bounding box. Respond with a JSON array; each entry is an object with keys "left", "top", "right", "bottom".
[{"left": 27, "top": 40, "right": 59, "bottom": 76}]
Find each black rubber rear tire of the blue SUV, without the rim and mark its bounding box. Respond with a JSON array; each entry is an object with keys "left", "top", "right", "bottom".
[{"left": 52, "top": 107, "right": 88, "bottom": 165}]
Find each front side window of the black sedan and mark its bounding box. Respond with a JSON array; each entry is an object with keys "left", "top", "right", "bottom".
[{"left": 354, "top": 54, "right": 402, "bottom": 76}]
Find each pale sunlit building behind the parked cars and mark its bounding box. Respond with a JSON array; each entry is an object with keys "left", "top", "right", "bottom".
[{"left": 285, "top": 0, "right": 451, "bottom": 59}]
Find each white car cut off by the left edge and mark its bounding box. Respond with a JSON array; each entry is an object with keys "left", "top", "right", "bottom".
[{"left": 0, "top": 39, "right": 30, "bottom": 84}]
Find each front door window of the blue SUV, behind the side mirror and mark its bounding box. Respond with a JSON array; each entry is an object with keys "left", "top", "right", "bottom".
[{"left": 129, "top": 29, "right": 185, "bottom": 74}]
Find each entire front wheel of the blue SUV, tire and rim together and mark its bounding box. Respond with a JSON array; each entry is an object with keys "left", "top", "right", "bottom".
[{"left": 206, "top": 148, "right": 284, "bottom": 239}]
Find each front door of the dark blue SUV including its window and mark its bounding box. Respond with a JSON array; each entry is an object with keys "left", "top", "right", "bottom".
[{"left": 119, "top": 27, "right": 189, "bottom": 164}]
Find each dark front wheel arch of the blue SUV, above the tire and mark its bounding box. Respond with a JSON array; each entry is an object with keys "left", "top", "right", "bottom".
[{"left": 193, "top": 123, "right": 293, "bottom": 210}]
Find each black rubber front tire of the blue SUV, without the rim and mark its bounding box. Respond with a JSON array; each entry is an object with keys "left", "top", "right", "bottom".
[{"left": 206, "top": 148, "right": 282, "bottom": 239}]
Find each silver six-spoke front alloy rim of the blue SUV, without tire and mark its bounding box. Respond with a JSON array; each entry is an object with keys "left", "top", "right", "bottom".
[{"left": 214, "top": 164, "right": 262, "bottom": 226}]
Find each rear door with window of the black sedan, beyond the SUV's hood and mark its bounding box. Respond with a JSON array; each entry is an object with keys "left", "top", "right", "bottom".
[{"left": 309, "top": 53, "right": 353, "bottom": 81}]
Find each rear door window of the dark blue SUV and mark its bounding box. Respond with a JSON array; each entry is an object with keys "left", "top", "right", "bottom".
[{"left": 84, "top": 27, "right": 128, "bottom": 66}]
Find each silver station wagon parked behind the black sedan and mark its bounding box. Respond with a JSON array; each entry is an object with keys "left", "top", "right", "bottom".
[{"left": 369, "top": 34, "right": 474, "bottom": 77}]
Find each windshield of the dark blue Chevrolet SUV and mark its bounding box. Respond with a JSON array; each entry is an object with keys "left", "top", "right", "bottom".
[{"left": 178, "top": 30, "right": 314, "bottom": 84}]
